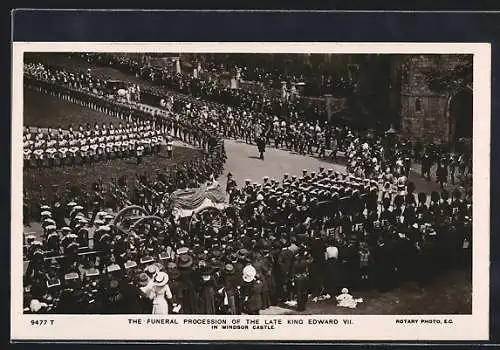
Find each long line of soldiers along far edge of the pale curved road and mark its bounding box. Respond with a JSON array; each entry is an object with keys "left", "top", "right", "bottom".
[{"left": 161, "top": 89, "right": 472, "bottom": 190}]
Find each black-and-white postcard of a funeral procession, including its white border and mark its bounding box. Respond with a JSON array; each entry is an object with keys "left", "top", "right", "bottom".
[{"left": 11, "top": 42, "right": 491, "bottom": 341}]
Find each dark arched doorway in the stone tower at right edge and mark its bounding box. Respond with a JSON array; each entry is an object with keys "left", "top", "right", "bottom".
[{"left": 450, "top": 89, "right": 473, "bottom": 145}]
